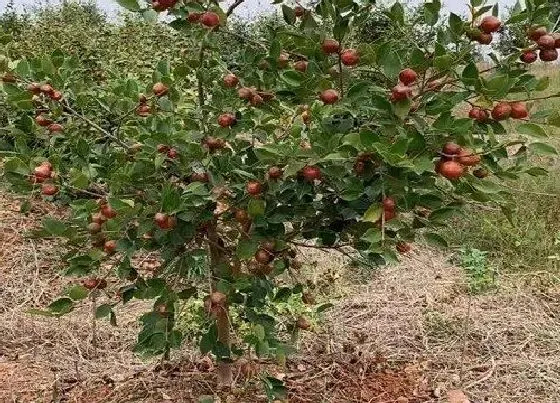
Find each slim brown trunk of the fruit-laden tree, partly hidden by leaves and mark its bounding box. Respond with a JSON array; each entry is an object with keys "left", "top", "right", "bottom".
[{"left": 207, "top": 222, "right": 233, "bottom": 387}]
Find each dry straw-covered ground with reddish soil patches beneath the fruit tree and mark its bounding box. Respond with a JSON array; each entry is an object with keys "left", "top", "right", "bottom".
[{"left": 0, "top": 194, "right": 560, "bottom": 403}]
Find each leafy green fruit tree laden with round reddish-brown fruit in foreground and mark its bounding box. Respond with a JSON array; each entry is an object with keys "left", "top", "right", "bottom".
[{"left": 0, "top": 0, "right": 560, "bottom": 392}]
